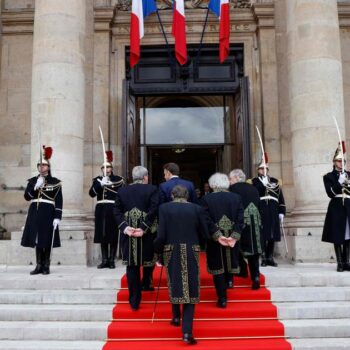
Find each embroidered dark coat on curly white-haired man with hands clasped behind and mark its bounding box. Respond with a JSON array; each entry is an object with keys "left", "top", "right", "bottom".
[{"left": 202, "top": 191, "right": 244, "bottom": 275}]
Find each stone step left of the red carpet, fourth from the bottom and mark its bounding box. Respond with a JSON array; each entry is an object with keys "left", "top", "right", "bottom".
[{"left": 0, "top": 289, "right": 116, "bottom": 305}]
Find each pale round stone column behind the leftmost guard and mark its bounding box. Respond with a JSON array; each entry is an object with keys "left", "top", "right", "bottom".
[{"left": 31, "top": 0, "right": 86, "bottom": 214}]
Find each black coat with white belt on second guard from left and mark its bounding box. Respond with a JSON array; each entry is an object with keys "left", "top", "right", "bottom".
[{"left": 89, "top": 174, "right": 124, "bottom": 243}]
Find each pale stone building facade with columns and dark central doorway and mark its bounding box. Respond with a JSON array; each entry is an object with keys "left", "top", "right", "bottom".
[{"left": 0, "top": 0, "right": 350, "bottom": 263}]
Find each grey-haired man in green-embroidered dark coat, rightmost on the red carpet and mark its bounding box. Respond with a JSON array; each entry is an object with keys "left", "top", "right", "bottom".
[{"left": 229, "top": 169, "right": 262, "bottom": 289}]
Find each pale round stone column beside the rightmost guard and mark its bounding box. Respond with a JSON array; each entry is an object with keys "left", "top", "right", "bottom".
[{"left": 286, "top": 0, "right": 344, "bottom": 260}]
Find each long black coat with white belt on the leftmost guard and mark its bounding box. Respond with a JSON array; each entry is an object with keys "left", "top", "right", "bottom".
[{"left": 21, "top": 175, "right": 63, "bottom": 248}]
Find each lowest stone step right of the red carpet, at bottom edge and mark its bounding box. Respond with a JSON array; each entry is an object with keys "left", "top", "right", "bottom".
[{"left": 288, "top": 338, "right": 350, "bottom": 350}]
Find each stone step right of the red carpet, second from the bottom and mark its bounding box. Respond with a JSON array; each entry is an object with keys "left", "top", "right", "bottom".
[{"left": 281, "top": 318, "right": 350, "bottom": 338}]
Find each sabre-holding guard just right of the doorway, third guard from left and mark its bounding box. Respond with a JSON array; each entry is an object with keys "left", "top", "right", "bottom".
[{"left": 252, "top": 153, "right": 286, "bottom": 266}]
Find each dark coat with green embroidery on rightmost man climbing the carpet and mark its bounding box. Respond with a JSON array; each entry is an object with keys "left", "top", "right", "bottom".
[{"left": 230, "top": 182, "right": 262, "bottom": 256}]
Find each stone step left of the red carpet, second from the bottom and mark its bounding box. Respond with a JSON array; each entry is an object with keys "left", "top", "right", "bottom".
[{"left": 0, "top": 321, "right": 109, "bottom": 341}]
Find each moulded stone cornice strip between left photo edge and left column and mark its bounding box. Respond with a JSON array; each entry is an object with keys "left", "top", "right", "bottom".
[{"left": 1, "top": 9, "right": 34, "bottom": 35}]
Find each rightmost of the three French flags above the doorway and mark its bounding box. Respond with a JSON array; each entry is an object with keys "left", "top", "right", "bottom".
[{"left": 208, "top": 0, "right": 230, "bottom": 63}]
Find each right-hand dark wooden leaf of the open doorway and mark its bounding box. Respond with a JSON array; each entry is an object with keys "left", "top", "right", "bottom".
[{"left": 234, "top": 77, "right": 251, "bottom": 178}]
